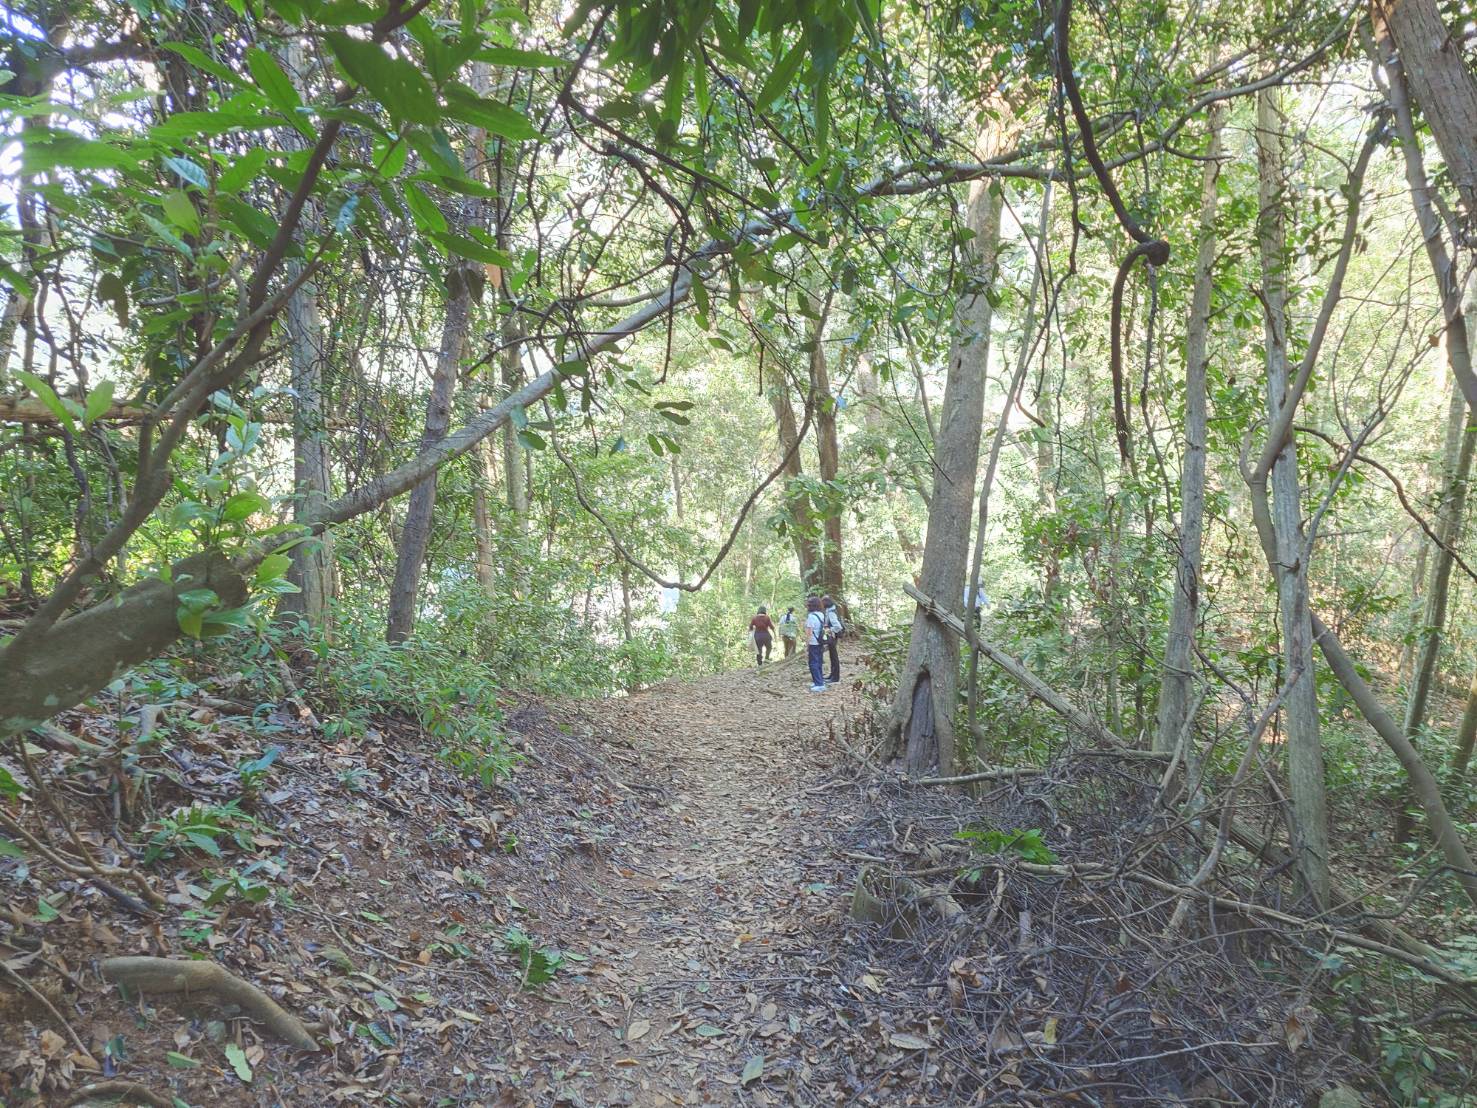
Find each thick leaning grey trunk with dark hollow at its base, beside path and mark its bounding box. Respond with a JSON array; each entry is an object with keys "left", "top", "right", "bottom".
[{"left": 891, "top": 166, "right": 1000, "bottom": 777}]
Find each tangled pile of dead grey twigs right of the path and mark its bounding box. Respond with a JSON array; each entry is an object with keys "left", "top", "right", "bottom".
[{"left": 849, "top": 741, "right": 1394, "bottom": 1105}]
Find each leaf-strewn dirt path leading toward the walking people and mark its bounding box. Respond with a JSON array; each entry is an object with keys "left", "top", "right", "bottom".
[{"left": 551, "top": 662, "right": 860, "bottom": 1105}]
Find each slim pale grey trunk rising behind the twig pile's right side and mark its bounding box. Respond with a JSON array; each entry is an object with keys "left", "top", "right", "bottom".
[{"left": 1257, "top": 89, "right": 1328, "bottom": 904}]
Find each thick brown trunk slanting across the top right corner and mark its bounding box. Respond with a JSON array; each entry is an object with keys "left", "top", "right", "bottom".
[{"left": 1371, "top": 0, "right": 1477, "bottom": 226}]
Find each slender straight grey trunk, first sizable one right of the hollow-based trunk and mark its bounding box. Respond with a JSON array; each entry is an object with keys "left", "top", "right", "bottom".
[{"left": 1154, "top": 105, "right": 1226, "bottom": 752}]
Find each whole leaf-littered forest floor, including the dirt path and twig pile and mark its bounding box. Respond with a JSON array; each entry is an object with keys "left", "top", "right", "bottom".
[{"left": 0, "top": 656, "right": 1429, "bottom": 1108}]
